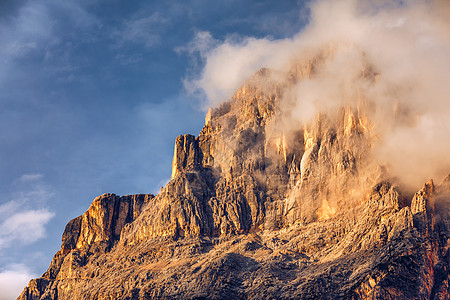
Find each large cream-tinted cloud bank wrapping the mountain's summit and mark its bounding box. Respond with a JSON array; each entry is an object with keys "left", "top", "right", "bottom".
[{"left": 187, "top": 0, "right": 450, "bottom": 187}]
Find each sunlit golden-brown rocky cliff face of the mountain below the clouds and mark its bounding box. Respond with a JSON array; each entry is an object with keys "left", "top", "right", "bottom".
[{"left": 18, "top": 58, "right": 450, "bottom": 299}]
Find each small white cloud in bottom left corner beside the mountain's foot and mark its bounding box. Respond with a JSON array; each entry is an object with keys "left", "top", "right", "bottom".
[{"left": 0, "top": 264, "right": 37, "bottom": 300}]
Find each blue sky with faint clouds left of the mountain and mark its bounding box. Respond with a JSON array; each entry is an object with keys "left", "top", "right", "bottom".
[{"left": 0, "top": 0, "right": 307, "bottom": 295}]
